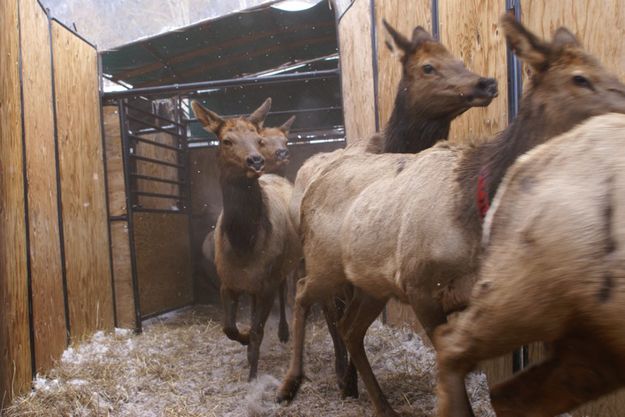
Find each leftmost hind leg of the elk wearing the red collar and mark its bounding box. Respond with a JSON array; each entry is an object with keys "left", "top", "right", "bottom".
[{"left": 276, "top": 277, "right": 316, "bottom": 402}]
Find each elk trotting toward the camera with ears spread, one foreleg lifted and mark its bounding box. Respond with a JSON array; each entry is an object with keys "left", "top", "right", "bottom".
[{"left": 192, "top": 101, "right": 301, "bottom": 380}]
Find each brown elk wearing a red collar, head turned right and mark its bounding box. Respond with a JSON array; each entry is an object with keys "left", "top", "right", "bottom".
[{"left": 282, "top": 15, "right": 625, "bottom": 416}]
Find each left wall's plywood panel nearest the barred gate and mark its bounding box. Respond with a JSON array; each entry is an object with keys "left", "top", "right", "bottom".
[{"left": 52, "top": 22, "right": 113, "bottom": 338}]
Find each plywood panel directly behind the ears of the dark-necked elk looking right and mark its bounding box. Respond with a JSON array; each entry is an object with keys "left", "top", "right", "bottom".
[{"left": 375, "top": 0, "right": 432, "bottom": 129}]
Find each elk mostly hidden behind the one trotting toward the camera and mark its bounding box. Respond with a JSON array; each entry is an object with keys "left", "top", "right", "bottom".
[{"left": 202, "top": 109, "right": 295, "bottom": 343}]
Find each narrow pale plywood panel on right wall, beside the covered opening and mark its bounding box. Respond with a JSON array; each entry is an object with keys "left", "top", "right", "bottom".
[{"left": 339, "top": 0, "right": 375, "bottom": 143}]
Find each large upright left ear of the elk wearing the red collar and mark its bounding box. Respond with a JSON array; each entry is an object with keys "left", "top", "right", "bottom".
[{"left": 501, "top": 13, "right": 550, "bottom": 71}]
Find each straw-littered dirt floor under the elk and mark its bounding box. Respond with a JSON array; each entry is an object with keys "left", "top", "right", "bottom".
[{"left": 6, "top": 306, "right": 494, "bottom": 417}]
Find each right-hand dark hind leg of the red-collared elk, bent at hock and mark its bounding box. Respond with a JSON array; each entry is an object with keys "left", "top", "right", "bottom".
[{"left": 339, "top": 289, "right": 397, "bottom": 417}]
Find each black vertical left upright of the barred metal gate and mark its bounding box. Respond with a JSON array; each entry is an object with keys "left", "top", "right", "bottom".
[{"left": 118, "top": 100, "right": 142, "bottom": 333}]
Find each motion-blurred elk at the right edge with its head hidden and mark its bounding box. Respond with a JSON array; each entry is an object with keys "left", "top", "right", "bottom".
[{"left": 435, "top": 112, "right": 625, "bottom": 417}]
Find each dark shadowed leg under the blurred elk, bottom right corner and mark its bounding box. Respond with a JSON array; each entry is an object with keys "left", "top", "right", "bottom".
[{"left": 491, "top": 338, "right": 620, "bottom": 417}]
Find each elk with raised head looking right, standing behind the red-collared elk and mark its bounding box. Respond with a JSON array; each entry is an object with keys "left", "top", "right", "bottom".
[{"left": 290, "top": 20, "right": 498, "bottom": 231}]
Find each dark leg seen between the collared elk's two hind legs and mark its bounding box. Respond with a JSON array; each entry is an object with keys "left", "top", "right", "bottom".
[{"left": 323, "top": 290, "right": 358, "bottom": 398}]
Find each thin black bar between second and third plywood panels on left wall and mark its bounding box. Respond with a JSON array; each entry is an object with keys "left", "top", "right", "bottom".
[{"left": 47, "top": 9, "right": 72, "bottom": 346}]
